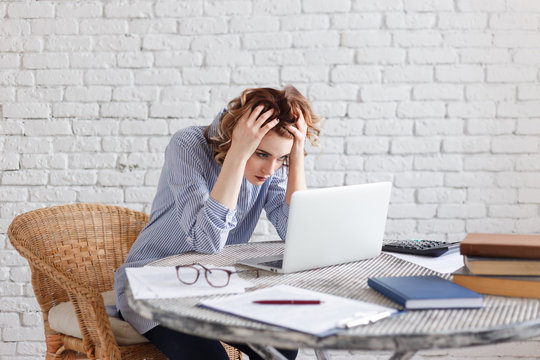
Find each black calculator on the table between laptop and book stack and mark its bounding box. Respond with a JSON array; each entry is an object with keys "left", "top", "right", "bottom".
[{"left": 382, "top": 239, "right": 460, "bottom": 257}]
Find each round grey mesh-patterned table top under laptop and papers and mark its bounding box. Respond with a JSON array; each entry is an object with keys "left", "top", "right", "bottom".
[{"left": 130, "top": 242, "right": 540, "bottom": 350}]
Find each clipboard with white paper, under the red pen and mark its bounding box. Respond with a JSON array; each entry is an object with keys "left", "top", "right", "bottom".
[{"left": 199, "top": 285, "right": 398, "bottom": 337}]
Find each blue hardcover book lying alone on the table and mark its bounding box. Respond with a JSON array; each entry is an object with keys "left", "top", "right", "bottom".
[{"left": 368, "top": 276, "right": 482, "bottom": 309}]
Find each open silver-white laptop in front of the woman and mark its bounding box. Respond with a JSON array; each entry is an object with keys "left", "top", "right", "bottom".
[{"left": 237, "top": 182, "right": 392, "bottom": 273}]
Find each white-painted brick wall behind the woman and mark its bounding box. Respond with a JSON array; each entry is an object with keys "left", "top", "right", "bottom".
[{"left": 0, "top": 0, "right": 540, "bottom": 360}]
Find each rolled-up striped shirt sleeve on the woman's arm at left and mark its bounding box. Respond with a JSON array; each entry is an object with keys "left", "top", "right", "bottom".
[{"left": 165, "top": 132, "right": 237, "bottom": 254}]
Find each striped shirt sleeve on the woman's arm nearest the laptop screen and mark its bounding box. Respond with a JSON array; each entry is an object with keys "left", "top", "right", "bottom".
[{"left": 264, "top": 167, "right": 289, "bottom": 240}]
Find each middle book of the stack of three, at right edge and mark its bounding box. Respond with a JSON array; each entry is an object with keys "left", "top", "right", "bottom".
[{"left": 463, "top": 255, "right": 540, "bottom": 276}]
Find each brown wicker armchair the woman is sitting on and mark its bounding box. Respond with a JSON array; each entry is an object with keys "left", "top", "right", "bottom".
[{"left": 8, "top": 204, "right": 241, "bottom": 360}]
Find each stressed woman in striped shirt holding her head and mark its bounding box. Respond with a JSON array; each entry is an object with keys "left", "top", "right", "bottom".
[{"left": 115, "top": 86, "right": 320, "bottom": 360}]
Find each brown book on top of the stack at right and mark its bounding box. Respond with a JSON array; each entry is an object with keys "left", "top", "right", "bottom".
[{"left": 459, "top": 233, "right": 540, "bottom": 259}]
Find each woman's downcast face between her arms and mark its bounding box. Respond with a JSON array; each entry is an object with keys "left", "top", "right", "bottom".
[{"left": 244, "top": 130, "right": 294, "bottom": 185}]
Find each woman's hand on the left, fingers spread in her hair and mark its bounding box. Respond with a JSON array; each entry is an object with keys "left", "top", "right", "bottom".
[{"left": 227, "top": 105, "right": 279, "bottom": 161}]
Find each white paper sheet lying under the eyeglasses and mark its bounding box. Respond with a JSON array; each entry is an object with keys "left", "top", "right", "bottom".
[{"left": 126, "top": 265, "right": 253, "bottom": 299}]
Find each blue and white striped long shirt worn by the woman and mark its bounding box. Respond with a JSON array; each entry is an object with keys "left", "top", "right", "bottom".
[{"left": 115, "top": 113, "right": 289, "bottom": 334}]
